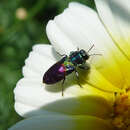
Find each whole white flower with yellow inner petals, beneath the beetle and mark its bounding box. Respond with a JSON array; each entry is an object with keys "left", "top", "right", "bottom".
[{"left": 10, "top": 0, "right": 130, "bottom": 130}]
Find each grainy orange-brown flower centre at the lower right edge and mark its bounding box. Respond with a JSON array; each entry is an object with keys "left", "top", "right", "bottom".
[{"left": 112, "top": 89, "right": 130, "bottom": 130}]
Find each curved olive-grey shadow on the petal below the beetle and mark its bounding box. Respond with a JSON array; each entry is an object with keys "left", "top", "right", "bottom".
[{"left": 21, "top": 95, "right": 112, "bottom": 119}]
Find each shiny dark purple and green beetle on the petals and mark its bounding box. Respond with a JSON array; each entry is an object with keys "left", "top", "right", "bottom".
[{"left": 43, "top": 45, "right": 97, "bottom": 96}]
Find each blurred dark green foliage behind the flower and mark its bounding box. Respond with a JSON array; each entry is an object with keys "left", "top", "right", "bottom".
[{"left": 0, "top": 0, "right": 95, "bottom": 130}]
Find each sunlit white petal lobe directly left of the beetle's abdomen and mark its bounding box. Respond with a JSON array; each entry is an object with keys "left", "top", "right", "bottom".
[{"left": 23, "top": 45, "right": 59, "bottom": 80}]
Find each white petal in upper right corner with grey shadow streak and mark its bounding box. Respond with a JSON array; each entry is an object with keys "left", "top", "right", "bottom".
[{"left": 95, "top": 0, "right": 130, "bottom": 59}]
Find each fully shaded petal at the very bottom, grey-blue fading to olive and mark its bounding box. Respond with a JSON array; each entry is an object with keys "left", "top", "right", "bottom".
[{"left": 9, "top": 115, "right": 113, "bottom": 130}]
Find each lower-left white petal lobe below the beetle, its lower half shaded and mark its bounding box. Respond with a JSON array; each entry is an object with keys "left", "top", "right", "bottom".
[{"left": 14, "top": 78, "right": 111, "bottom": 118}]
